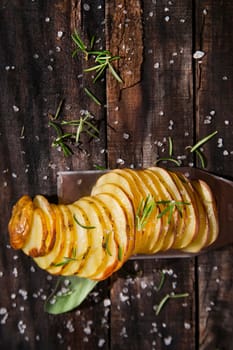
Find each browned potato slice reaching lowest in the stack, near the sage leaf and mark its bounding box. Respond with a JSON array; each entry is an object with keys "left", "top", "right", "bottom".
[{"left": 80, "top": 196, "right": 118, "bottom": 280}]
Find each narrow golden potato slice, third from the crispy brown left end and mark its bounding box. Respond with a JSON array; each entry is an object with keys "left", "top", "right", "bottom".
[{"left": 33, "top": 195, "right": 56, "bottom": 253}]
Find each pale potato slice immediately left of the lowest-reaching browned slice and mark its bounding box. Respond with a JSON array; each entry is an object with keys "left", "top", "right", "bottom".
[{"left": 73, "top": 197, "right": 105, "bottom": 278}]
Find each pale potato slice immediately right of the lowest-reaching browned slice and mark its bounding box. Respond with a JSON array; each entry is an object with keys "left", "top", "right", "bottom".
[{"left": 93, "top": 193, "right": 128, "bottom": 271}]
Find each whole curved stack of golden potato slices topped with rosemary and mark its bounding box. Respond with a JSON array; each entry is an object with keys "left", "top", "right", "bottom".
[{"left": 8, "top": 167, "right": 219, "bottom": 280}]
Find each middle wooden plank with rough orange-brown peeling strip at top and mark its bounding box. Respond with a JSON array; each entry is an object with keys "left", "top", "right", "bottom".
[{"left": 106, "top": 0, "right": 195, "bottom": 349}]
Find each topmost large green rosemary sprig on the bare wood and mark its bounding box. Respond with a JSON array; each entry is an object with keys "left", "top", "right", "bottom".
[{"left": 71, "top": 30, "right": 123, "bottom": 83}]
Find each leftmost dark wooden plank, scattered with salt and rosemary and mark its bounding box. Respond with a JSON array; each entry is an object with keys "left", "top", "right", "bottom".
[{"left": 0, "top": 0, "right": 109, "bottom": 349}]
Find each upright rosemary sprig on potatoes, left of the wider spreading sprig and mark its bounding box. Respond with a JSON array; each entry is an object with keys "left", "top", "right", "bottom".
[{"left": 135, "top": 195, "right": 156, "bottom": 231}]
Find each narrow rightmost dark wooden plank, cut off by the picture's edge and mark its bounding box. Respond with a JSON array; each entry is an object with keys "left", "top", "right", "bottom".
[{"left": 196, "top": 1, "right": 233, "bottom": 350}]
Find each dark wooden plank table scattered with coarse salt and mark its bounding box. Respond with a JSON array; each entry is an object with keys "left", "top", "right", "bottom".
[{"left": 0, "top": 0, "right": 233, "bottom": 350}]
